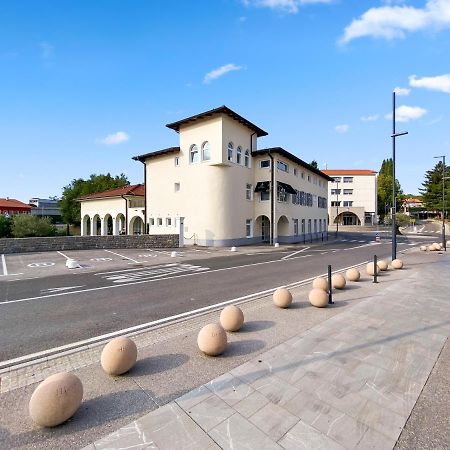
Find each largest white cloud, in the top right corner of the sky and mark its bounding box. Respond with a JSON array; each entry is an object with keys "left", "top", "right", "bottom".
[{"left": 340, "top": 0, "right": 450, "bottom": 44}]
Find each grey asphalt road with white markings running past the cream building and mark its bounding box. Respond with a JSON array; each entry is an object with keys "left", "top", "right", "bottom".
[{"left": 0, "top": 234, "right": 432, "bottom": 361}]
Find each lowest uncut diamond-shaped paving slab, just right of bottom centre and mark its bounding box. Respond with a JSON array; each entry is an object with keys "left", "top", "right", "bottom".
[{"left": 249, "top": 403, "right": 299, "bottom": 441}]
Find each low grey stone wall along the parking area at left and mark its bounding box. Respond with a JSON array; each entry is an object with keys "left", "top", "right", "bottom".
[{"left": 0, "top": 234, "right": 178, "bottom": 254}]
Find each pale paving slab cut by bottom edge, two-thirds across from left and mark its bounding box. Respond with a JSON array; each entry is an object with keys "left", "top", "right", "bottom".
[{"left": 278, "top": 420, "right": 345, "bottom": 450}]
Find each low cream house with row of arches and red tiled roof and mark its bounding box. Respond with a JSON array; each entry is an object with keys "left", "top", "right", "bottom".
[{"left": 78, "top": 184, "right": 145, "bottom": 236}]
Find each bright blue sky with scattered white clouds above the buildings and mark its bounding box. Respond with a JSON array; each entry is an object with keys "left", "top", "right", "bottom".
[{"left": 0, "top": 0, "right": 450, "bottom": 202}]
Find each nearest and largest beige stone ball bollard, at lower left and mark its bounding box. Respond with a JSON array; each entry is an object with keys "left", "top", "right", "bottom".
[{"left": 28, "top": 372, "right": 83, "bottom": 427}]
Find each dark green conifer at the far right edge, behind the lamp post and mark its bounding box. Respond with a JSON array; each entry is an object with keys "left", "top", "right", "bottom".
[{"left": 419, "top": 161, "right": 450, "bottom": 218}]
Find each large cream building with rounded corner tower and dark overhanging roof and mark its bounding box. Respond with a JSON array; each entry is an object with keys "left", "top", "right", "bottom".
[{"left": 133, "top": 106, "right": 331, "bottom": 246}]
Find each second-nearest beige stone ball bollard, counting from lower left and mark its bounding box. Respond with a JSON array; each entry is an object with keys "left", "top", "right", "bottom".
[{"left": 100, "top": 336, "right": 137, "bottom": 375}]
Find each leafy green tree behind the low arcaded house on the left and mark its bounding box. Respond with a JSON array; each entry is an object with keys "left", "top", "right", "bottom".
[{"left": 59, "top": 173, "right": 130, "bottom": 225}]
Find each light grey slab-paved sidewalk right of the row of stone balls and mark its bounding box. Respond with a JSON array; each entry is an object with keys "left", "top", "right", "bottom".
[{"left": 81, "top": 256, "right": 450, "bottom": 450}]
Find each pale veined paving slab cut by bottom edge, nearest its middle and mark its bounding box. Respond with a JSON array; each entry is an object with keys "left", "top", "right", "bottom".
[{"left": 209, "top": 413, "right": 282, "bottom": 450}]
